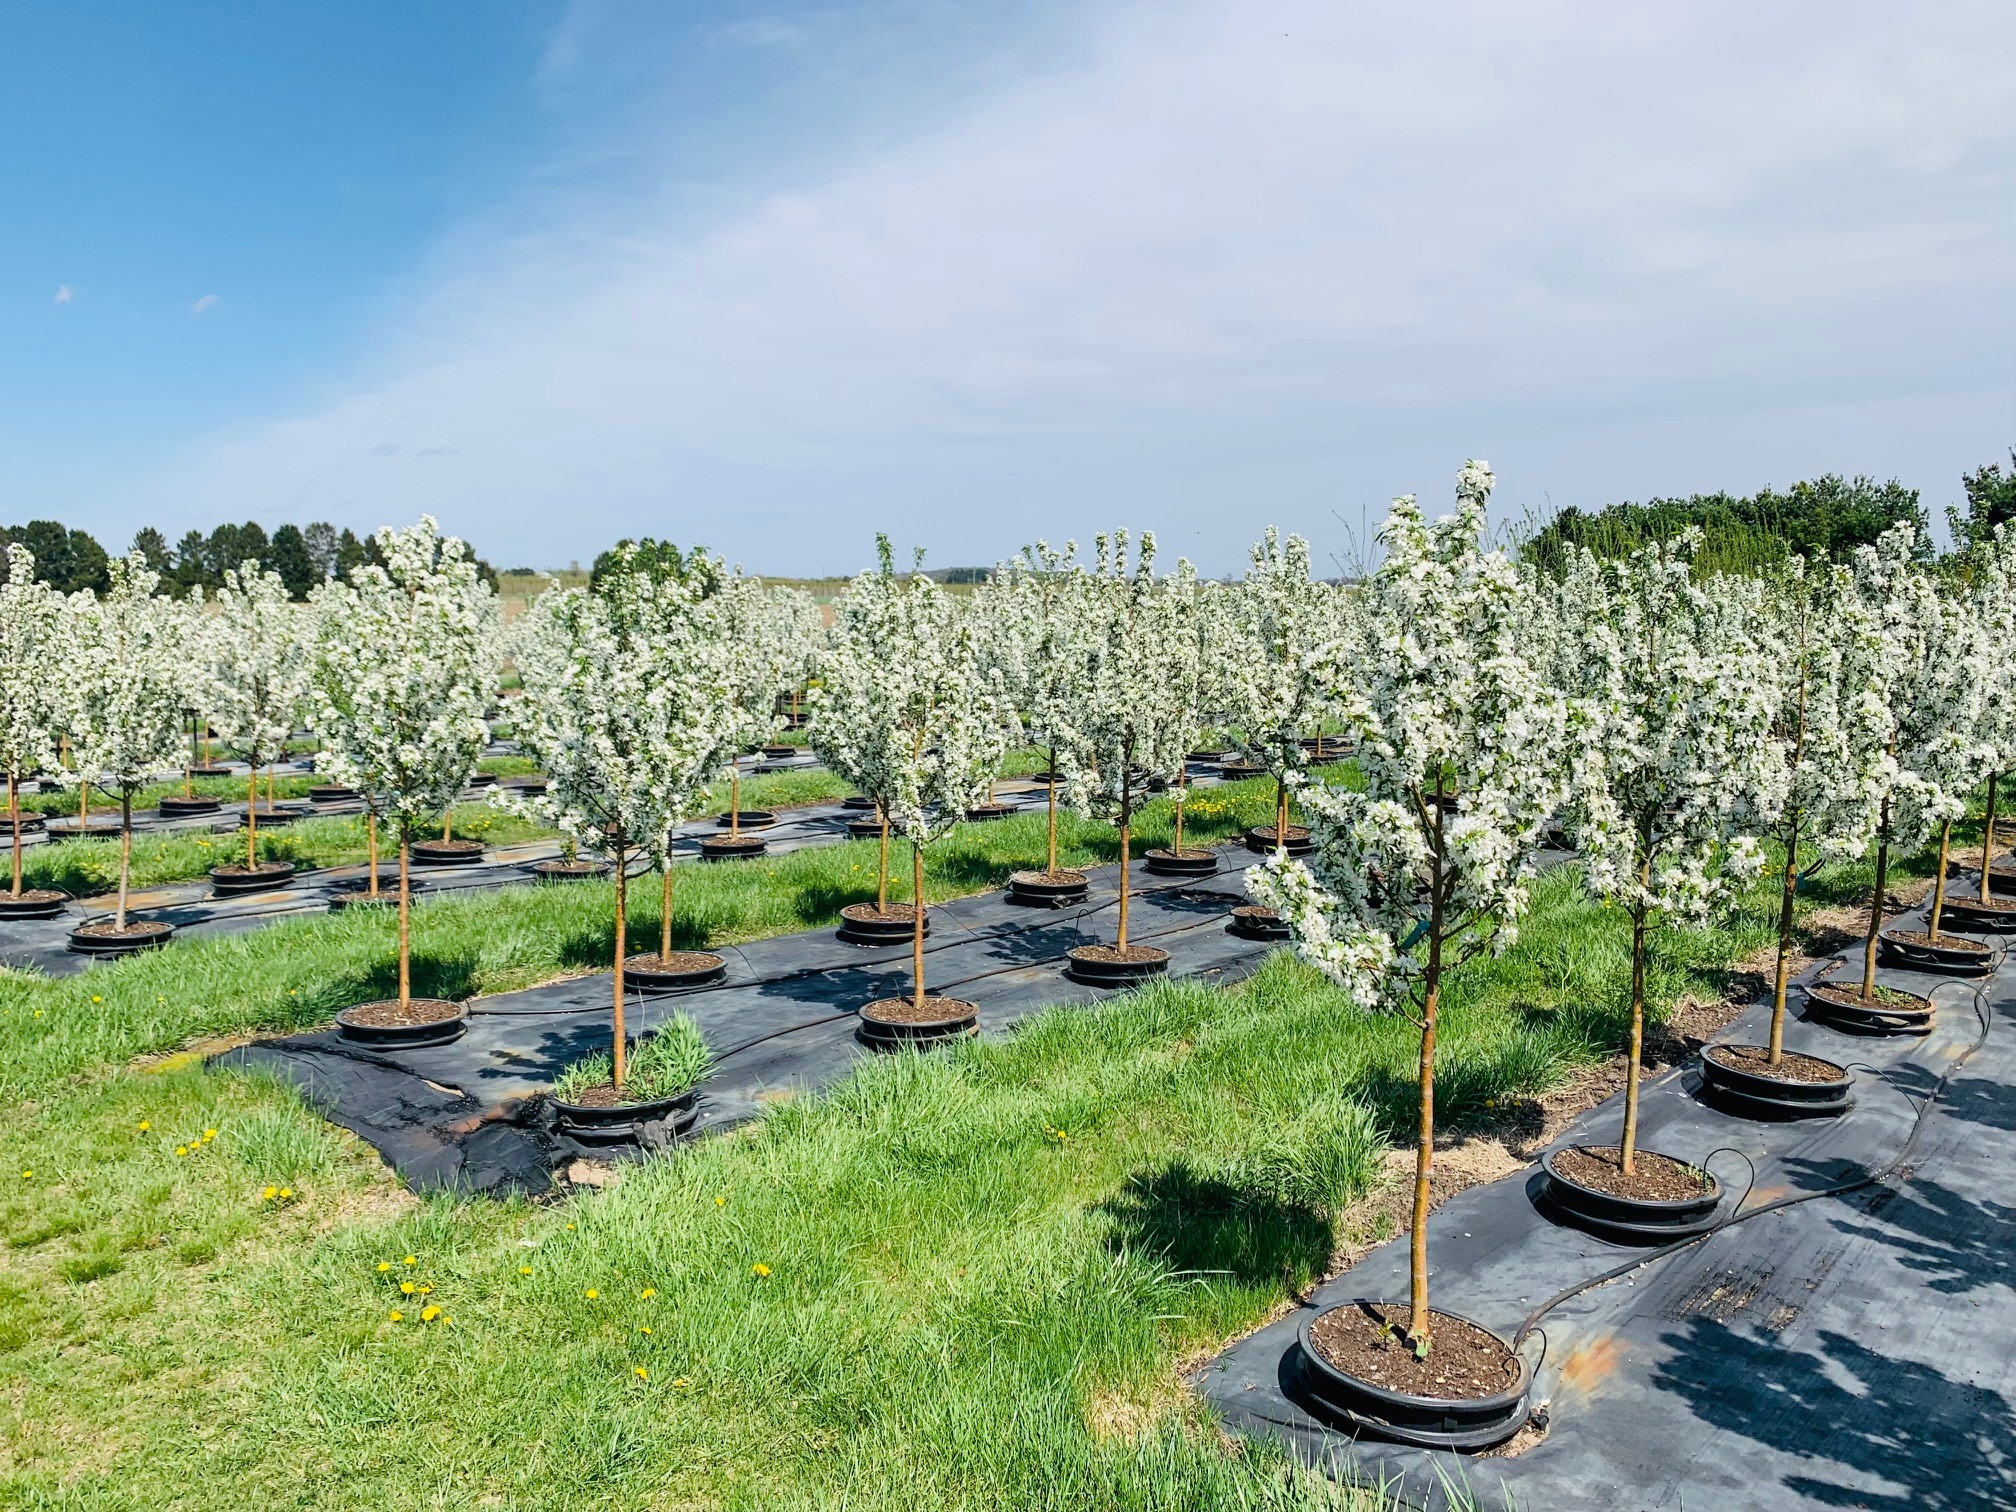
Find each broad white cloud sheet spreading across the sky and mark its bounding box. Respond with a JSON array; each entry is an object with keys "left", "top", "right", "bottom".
[{"left": 138, "top": 0, "right": 2016, "bottom": 571}]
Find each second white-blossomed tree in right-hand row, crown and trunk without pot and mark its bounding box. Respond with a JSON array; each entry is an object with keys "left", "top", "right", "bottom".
[{"left": 1558, "top": 532, "right": 1778, "bottom": 1175}]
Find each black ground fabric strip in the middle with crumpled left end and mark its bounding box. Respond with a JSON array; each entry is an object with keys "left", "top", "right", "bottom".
[{"left": 218, "top": 851, "right": 1270, "bottom": 1193}]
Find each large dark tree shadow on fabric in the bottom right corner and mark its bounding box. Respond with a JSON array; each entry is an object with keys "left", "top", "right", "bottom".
[{"left": 1653, "top": 1318, "right": 2016, "bottom": 1512}]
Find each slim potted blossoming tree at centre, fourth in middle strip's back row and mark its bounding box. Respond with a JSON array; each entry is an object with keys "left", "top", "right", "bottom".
[{"left": 974, "top": 540, "right": 1091, "bottom": 907}]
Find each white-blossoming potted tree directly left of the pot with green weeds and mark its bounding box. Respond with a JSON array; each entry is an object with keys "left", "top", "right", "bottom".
[{"left": 310, "top": 516, "right": 498, "bottom": 1048}]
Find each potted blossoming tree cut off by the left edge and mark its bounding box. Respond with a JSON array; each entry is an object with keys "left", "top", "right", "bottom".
[{"left": 0, "top": 544, "right": 75, "bottom": 919}]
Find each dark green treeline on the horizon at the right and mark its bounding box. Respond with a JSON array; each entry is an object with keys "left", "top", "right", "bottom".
[{"left": 1526, "top": 452, "right": 2016, "bottom": 573}]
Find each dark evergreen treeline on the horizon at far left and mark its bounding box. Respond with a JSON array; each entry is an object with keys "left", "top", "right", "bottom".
[{"left": 0, "top": 520, "right": 496, "bottom": 599}]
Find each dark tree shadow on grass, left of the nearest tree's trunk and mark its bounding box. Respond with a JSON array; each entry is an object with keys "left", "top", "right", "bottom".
[{"left": 1097, "top": 1159, "right": 1333, "bottom": 1288}]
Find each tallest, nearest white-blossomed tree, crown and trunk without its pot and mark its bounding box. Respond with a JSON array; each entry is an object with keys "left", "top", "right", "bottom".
[{"left": 1246, "top": 462, "right": 1566, "bottom": 1355}]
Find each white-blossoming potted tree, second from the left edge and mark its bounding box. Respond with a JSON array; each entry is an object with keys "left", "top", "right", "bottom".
[{"left": 69, "top": 552, "right": 185, "bottom": 956}]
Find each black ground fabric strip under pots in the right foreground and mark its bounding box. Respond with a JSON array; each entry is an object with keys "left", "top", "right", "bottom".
[{"left": 1191, "top": 899, "right": 2016, "bottom": 1512}]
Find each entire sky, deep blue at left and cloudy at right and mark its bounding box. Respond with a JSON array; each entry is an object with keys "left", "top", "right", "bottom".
[{"left": 0, "top": 0, "right": 2016, "bottom": 573}]
